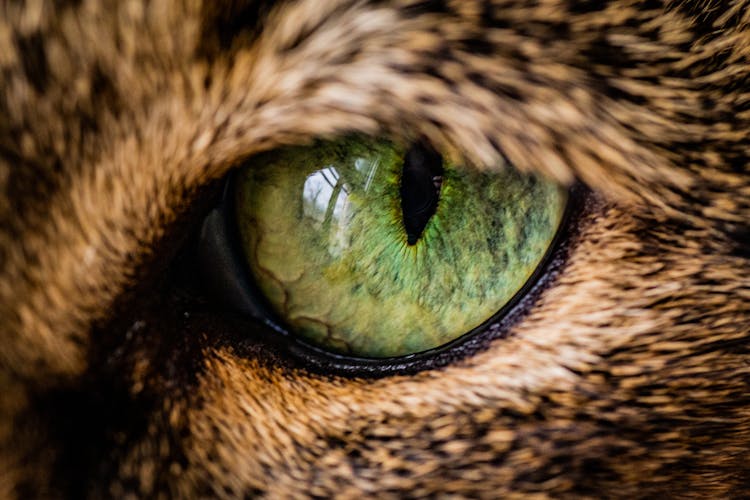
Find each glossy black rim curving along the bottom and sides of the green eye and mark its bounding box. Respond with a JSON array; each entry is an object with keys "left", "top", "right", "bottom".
[{"left": 197, "top": 166, "right": 592, "bottom": 378}]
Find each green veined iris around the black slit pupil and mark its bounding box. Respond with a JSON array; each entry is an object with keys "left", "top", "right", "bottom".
[{"left": 236, "top": 137, "right": 567, "bottom": 358}]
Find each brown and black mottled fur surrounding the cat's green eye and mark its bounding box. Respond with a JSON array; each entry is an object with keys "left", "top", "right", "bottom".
[{"left": 0, "top": 0, "right": 750, "bottom": 497}]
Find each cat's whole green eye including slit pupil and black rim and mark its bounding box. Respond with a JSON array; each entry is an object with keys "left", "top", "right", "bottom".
[{"left": 198, "top": 137, "right": 574, "bottom": 375}]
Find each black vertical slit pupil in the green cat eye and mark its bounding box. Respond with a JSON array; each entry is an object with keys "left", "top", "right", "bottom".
[{"left": 401, "top": 143, "right": 443, "bottom": 245}]
